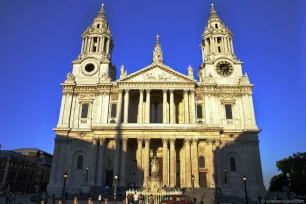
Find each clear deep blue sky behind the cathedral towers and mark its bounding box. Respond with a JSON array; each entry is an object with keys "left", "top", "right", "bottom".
[{"left": 0, "top": 0, "right": 306, "bottom": 188}]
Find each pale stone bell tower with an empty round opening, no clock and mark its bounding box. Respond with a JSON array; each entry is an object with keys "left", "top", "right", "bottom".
[{"left": 72, "top": 4, "right": 116, "bottom": 83}]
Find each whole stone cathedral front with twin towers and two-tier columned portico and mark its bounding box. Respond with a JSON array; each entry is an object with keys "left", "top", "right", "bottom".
[{"left": 48, "top": 4, "right": 265, "bottom": 201}]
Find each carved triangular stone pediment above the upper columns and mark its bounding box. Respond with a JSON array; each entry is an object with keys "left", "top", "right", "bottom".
[{"left": 117, "top": 63, "right": 196, "bottom": 83}]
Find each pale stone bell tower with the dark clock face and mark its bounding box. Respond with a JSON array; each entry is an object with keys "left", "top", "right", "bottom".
[{"left": 198, "top": 3, "right": 246, "bottom": 84}]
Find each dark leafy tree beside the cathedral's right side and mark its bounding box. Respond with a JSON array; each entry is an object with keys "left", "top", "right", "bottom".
[{"left": 269, "top": 152, "right": 306, "bottom": 196}]
